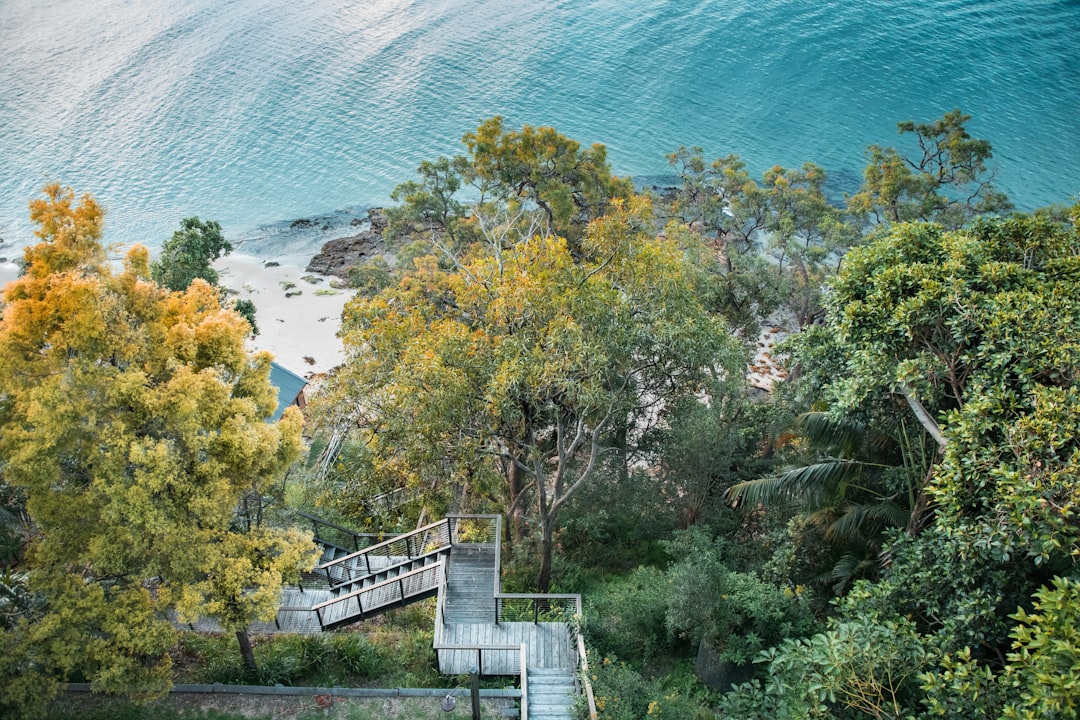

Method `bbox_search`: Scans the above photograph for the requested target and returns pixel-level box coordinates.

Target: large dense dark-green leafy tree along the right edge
[734,205,1080,717]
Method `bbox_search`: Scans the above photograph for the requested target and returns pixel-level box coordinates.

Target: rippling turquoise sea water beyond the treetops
[0,0,1080,255]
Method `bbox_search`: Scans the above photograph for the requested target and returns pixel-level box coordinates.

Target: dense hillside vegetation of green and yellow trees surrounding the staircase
[0,111,1080,720]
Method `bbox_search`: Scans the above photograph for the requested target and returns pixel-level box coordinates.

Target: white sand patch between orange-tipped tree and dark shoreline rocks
[214,253,352,379]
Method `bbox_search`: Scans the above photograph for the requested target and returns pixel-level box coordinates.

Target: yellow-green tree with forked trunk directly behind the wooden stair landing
[319,199,744,589]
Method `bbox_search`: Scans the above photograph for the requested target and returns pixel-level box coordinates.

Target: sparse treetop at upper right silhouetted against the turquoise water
[849,109,1012,228]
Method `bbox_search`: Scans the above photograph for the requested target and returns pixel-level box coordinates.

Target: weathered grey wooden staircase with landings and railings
[199,515,596,720]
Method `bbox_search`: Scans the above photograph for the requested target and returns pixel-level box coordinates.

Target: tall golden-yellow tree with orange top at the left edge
[0,185,313,712]
